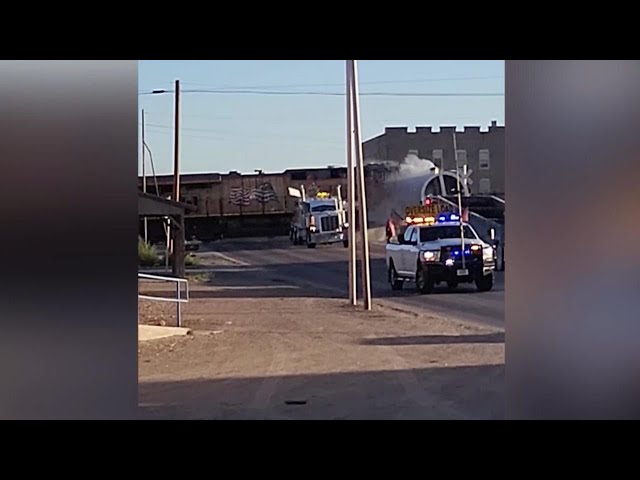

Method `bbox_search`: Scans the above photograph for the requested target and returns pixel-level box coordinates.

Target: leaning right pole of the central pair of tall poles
[347,60,371,310]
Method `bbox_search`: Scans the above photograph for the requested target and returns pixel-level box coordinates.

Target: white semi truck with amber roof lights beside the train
[289,186,349,248]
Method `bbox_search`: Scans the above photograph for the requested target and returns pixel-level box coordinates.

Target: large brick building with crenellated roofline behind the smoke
[363,121,505,196]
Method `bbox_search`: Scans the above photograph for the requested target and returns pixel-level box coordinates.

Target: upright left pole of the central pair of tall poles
[346,61,358,305]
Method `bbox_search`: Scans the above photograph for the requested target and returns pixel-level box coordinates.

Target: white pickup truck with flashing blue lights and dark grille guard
[386,213,495,293]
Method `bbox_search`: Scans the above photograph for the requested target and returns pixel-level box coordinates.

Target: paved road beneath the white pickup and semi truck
[202,238,504,328]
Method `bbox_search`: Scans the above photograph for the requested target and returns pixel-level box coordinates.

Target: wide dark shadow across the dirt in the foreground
[139,365,504,420]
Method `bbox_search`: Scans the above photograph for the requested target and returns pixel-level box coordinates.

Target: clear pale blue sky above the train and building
[138,60,504,175]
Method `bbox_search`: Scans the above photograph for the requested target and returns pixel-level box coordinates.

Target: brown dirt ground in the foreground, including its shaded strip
[139,275,504,419]
